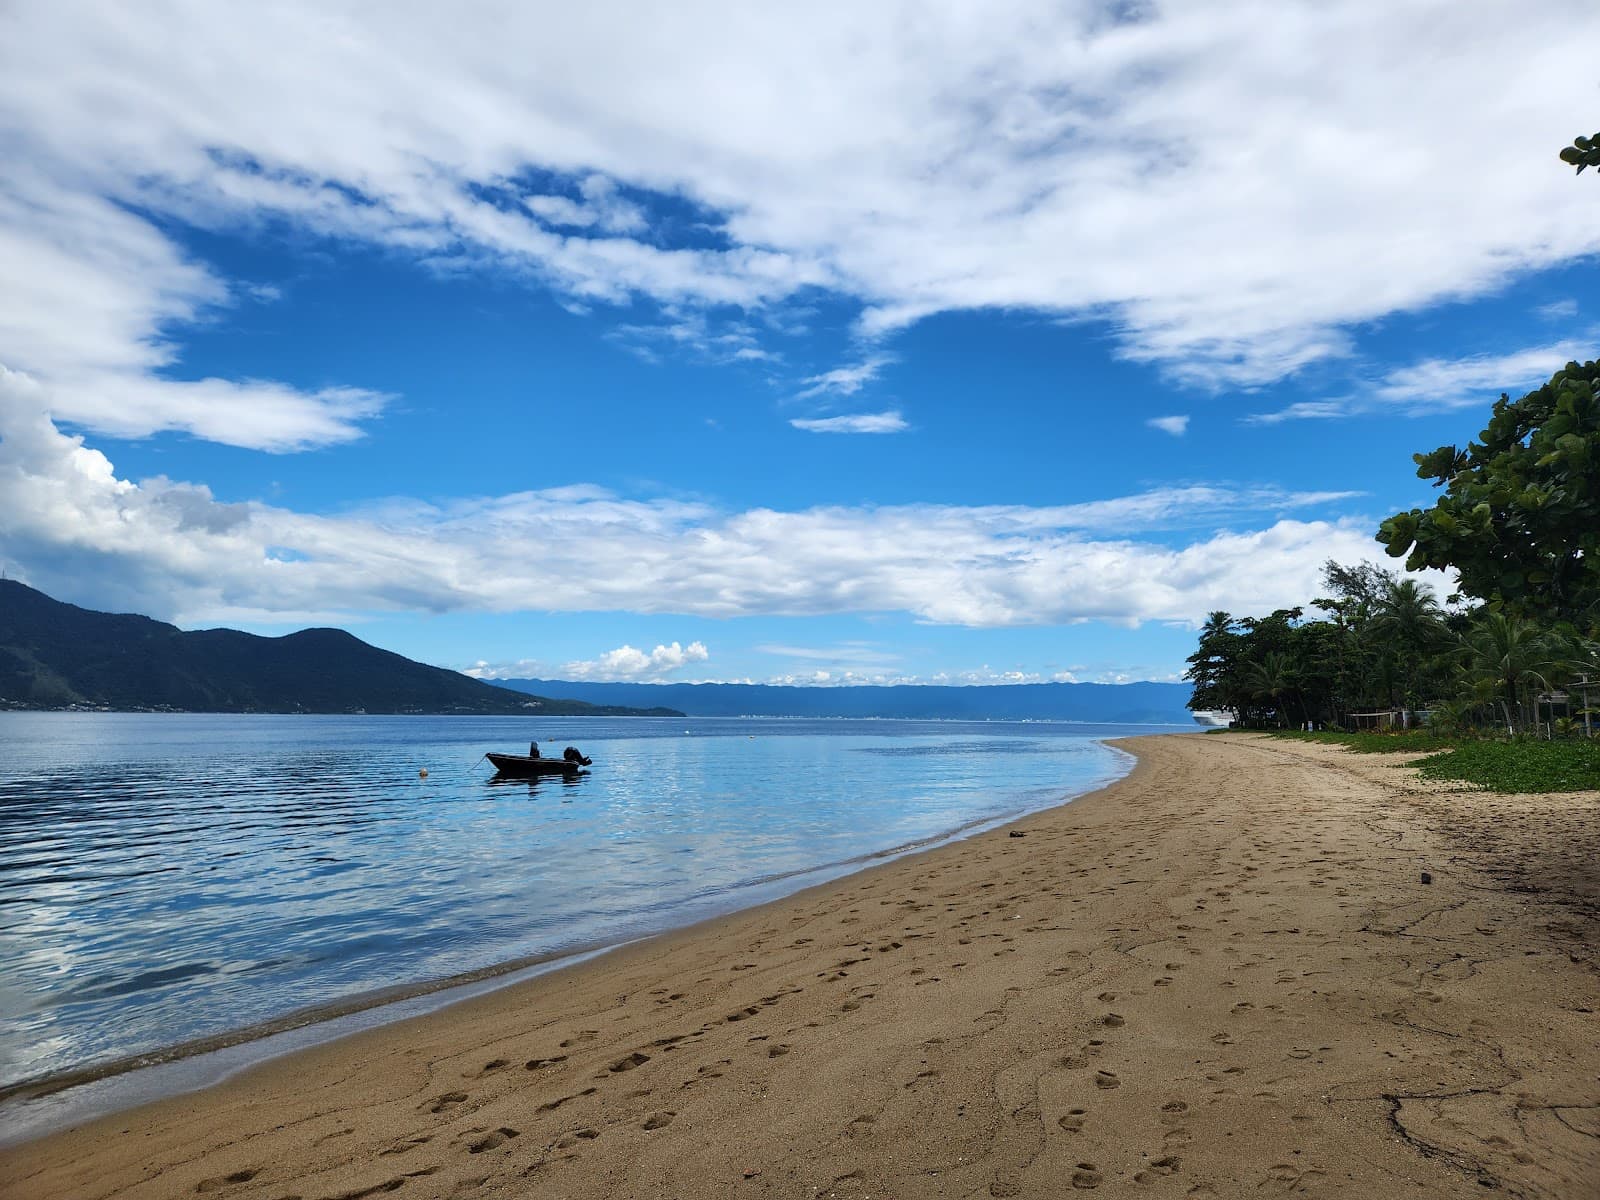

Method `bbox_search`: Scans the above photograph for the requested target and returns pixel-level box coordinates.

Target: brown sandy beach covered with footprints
[0,734,1600,1200]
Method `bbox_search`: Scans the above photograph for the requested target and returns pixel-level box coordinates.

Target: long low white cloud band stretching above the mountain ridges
[0,385,1440,633]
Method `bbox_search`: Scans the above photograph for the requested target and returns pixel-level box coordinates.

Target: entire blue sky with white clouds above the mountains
[0,2,1600,683]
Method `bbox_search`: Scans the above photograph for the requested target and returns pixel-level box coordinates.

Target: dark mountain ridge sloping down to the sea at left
[0,579,682,717]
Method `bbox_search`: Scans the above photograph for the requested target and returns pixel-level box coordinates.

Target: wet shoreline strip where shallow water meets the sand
[0,742,1139,1150]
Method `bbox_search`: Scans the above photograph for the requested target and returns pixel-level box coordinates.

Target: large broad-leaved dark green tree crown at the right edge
[1378,362,1600,626]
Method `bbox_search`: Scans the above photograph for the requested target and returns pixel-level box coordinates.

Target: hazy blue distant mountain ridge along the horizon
[498,678,1194,725]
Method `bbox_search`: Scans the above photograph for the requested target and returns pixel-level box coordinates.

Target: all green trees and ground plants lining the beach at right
[1186,362,1600,790]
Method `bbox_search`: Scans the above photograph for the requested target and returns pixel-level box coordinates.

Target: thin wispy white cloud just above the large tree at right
[1250,339,1595,424]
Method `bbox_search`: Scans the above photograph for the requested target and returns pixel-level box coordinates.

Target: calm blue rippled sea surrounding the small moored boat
[0,712,1162,1083]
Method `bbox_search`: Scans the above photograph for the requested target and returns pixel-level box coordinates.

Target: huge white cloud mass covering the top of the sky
[0,0,1600,409]
